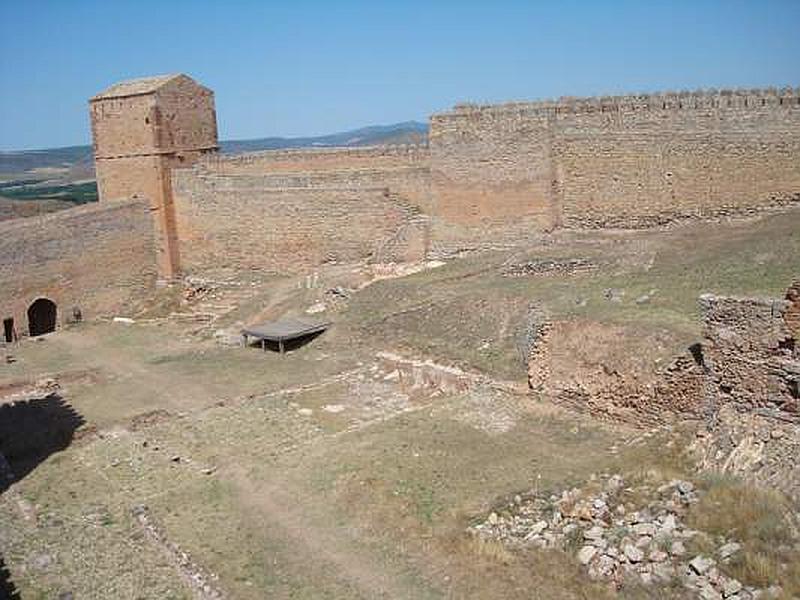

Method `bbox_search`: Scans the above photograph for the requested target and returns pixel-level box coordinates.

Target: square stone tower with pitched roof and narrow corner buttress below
[89,74,218,281]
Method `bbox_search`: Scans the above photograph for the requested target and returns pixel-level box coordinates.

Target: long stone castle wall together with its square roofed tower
[84,77,800,282]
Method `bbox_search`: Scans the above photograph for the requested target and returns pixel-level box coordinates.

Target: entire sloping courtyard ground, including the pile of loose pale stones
[0,212,800,600]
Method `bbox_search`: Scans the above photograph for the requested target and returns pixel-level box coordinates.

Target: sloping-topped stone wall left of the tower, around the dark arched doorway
[0,201,156,334]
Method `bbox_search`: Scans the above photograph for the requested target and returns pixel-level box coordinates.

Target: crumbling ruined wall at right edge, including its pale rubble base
[692,283,800,496]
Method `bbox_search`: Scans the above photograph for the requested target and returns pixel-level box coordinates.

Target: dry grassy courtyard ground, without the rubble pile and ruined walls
[0,212,800,599]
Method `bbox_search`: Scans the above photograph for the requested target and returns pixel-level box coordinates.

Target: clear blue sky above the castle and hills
[0,0,800,150]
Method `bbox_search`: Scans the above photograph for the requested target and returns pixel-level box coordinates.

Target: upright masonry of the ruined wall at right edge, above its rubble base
[700,295,800,421]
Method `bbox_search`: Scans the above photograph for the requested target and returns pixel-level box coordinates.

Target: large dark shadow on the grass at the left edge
[0,394,84,493]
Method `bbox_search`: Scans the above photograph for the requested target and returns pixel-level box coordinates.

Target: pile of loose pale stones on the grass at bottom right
[471,475,779,600]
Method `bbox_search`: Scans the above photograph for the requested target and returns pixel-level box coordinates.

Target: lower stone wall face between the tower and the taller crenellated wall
[174,170,424,274]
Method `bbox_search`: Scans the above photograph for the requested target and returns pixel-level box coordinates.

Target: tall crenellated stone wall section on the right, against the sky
[430,89,800,229]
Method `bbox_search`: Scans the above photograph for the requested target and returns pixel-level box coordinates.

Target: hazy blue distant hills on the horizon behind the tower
[0,121,428,179]
